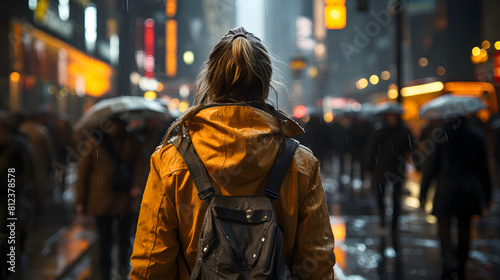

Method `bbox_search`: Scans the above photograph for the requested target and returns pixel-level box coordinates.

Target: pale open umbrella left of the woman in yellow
[74,96,170,131]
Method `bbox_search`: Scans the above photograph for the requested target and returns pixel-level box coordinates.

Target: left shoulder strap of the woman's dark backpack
[171,124,216,201]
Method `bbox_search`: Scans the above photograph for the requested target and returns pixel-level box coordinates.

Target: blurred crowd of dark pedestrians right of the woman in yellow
[301,106,500,279]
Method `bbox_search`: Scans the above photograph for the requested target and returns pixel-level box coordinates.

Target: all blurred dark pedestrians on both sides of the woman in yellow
[0,97,499,279]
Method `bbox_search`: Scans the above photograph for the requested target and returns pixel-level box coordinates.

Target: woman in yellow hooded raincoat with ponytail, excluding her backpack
[131,27,335,279]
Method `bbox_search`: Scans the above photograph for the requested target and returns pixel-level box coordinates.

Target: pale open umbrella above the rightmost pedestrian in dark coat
[419,94,487,120]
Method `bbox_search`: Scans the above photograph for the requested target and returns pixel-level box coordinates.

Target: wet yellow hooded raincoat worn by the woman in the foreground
[130,105,335,280]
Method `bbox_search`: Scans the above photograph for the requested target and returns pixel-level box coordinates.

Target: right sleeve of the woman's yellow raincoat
[290,161,335,279]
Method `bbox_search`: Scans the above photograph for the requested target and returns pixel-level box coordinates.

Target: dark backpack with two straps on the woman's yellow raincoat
[173,127,299,280]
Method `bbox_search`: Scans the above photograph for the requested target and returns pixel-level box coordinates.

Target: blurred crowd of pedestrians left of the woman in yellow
[0,110,168,279]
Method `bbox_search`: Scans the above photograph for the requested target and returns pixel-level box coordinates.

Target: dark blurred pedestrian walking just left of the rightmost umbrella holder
[369,113,413,240]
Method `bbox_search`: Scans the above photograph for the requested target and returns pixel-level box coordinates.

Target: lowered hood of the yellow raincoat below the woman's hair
[186,105,304,191]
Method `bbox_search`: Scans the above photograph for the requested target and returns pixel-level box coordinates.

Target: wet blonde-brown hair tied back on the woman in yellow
[162,27,277,145]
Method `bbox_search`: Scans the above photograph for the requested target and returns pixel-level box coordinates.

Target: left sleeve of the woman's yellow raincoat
[130,153,179,280]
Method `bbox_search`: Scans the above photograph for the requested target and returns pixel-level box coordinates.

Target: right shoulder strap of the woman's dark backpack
[264,138,299,200]
